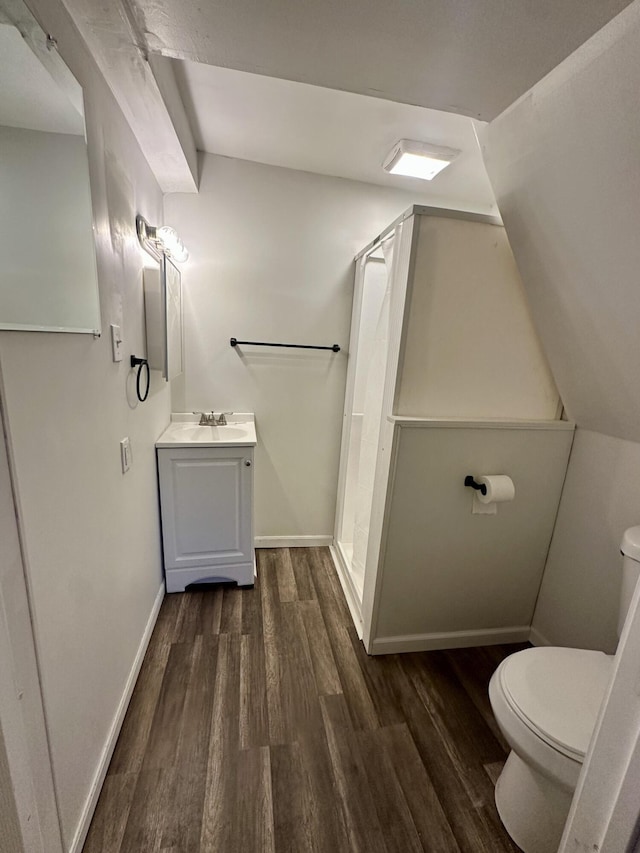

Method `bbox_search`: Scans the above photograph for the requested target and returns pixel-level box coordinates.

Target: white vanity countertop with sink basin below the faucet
[156,412,257,447]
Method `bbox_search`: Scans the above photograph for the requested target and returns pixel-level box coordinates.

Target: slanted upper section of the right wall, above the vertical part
[483,3,640,442]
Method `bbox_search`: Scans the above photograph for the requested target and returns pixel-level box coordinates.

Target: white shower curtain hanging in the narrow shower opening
[351,237,394,595]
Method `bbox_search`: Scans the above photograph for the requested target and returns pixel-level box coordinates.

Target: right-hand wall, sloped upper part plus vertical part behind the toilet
[483,0,640,650]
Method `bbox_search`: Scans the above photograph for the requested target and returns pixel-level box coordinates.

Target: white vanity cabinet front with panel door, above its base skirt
[158,447,253,569]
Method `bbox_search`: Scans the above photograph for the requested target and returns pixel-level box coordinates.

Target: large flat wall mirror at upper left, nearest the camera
[0,0,100,335]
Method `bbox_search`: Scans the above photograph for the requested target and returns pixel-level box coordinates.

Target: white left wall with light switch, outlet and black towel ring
[0,0,170,849]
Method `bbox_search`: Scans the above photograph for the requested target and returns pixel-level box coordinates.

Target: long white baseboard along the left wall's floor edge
[69,581,165,853]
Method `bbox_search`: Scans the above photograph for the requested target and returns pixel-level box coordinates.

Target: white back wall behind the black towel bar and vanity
[165,154,450,537]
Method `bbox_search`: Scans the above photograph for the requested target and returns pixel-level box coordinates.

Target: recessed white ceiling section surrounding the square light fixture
[174,61,495,212]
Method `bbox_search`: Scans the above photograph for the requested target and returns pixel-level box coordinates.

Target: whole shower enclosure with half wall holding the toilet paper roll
[334,207,573,653]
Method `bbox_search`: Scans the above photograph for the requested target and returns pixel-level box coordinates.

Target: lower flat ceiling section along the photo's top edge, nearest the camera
[135,0,630,120]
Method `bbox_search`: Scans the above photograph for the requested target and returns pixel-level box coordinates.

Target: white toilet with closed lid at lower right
[489,527,640,853]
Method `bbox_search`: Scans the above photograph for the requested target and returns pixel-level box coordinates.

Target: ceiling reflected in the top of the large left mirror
[0,24,84,135]
